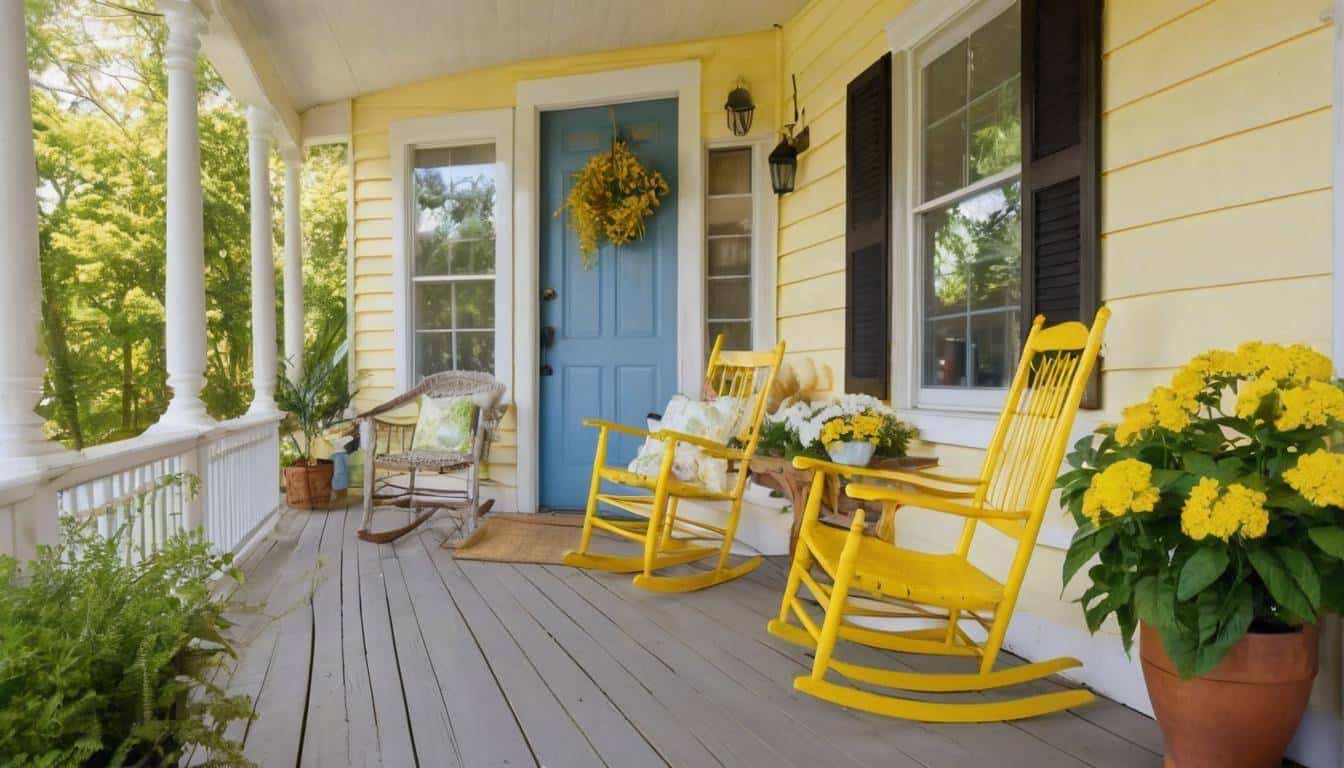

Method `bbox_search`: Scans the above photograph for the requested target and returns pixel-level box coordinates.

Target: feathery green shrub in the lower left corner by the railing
[0,477,251,767]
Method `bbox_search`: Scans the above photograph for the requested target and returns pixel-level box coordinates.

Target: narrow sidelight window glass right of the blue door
[706,147,754,350]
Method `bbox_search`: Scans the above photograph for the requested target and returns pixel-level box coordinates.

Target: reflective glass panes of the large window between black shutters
[915,4,1021,387]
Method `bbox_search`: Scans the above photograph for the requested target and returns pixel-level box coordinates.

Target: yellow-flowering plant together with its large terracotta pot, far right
[1059,342,1344,768]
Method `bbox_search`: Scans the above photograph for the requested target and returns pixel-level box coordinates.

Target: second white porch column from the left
[157,0,215,428]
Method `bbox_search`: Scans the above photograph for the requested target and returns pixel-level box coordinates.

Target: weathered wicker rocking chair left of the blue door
[355,371,505,543]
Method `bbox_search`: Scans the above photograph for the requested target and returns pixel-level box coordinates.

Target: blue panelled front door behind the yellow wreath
[540,100,677,510]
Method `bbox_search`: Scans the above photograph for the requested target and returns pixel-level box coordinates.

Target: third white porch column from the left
[247,106,277,413]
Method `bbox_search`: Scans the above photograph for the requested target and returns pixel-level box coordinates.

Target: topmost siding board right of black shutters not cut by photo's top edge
[1102,28,1333,171]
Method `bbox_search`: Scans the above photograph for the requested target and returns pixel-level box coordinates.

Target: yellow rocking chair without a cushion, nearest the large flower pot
[767,308,1110,722]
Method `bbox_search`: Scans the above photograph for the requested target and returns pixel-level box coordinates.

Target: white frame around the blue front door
[513,61,704,512]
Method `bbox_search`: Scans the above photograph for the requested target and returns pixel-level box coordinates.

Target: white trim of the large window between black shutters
[887,0,1020,449]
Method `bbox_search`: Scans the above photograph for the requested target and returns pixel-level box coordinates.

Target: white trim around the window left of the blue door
[387,109,513,398]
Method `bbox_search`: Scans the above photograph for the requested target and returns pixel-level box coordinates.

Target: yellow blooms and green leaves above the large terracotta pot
[1059,342,1344,678]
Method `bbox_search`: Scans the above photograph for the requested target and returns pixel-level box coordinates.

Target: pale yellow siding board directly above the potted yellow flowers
[1106,276,1331,369]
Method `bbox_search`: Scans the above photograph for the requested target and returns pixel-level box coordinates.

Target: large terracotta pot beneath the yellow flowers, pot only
[1140,624,1317,768]
